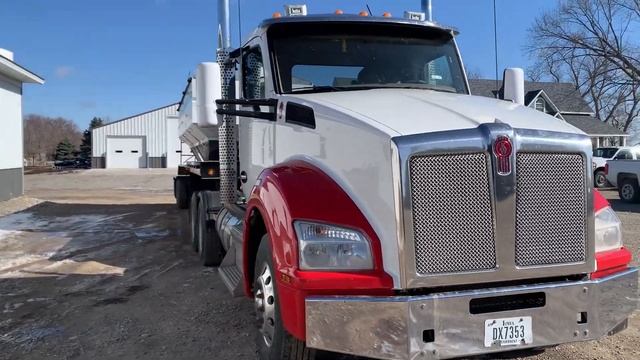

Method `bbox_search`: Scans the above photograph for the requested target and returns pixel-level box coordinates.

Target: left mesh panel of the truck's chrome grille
[409,153,496,275]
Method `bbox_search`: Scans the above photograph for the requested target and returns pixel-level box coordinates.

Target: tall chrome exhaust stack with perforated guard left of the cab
[216,0,238,204]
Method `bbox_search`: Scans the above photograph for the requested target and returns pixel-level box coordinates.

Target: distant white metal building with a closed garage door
[91,104,191,169]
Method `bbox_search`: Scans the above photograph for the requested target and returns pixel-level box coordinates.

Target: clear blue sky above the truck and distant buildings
[0,0,557,128]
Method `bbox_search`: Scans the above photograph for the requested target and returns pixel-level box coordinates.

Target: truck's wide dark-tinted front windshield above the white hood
[269,23,467,94]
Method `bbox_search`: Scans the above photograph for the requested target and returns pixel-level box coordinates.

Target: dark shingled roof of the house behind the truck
[469,79,593,114]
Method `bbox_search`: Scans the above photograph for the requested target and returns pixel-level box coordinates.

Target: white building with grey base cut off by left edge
[0,49,44,201]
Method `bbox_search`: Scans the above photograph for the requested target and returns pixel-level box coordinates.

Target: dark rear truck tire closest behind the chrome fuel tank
[198,191,224,266]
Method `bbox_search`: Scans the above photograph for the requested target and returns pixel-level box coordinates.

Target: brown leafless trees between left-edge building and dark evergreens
[24,114,82,163]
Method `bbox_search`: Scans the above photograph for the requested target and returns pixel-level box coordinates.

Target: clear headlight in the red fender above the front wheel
[293,221,373,270]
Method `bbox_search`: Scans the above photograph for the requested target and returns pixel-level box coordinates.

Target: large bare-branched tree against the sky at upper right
[527,0,640,131]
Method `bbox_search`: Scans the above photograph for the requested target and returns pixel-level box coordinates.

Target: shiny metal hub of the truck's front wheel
[254,264,276,347]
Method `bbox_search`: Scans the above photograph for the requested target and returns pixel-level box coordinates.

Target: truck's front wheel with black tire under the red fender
[253,235,316,360]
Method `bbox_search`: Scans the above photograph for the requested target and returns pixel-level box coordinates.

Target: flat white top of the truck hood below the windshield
[293,89,584,136]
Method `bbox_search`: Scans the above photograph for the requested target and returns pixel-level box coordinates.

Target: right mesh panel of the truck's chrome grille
[515,153,587,266]
